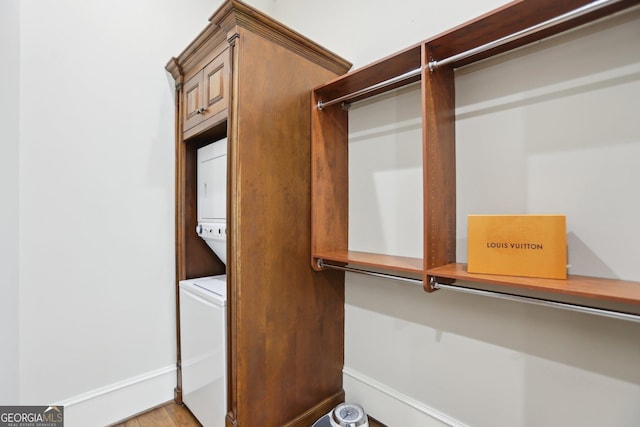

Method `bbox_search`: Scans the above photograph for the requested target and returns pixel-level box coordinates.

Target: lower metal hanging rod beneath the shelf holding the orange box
[430,276,640,323]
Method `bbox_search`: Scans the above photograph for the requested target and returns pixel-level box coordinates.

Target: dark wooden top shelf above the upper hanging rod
[315,0,638,110]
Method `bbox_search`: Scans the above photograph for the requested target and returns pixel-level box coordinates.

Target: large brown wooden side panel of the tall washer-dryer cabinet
[231,30,344,426]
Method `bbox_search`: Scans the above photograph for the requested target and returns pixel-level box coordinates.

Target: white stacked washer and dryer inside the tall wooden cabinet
[179,138,227,427]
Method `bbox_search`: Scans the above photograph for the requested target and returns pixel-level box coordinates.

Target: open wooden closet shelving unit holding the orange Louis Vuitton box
[311,0,640,318]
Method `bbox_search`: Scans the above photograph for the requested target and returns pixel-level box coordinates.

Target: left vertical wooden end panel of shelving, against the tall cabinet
[311,93,349,269]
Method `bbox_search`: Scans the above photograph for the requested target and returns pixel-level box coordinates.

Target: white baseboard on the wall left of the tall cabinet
[56,366,176,427]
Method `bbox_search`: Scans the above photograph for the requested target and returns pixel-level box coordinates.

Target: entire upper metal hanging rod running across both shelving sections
[316,0,623,110]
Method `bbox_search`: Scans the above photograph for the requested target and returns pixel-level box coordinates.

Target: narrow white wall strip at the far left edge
[0,0,20,405]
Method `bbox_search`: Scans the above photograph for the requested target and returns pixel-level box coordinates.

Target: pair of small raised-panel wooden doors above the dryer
[183,49,230,136]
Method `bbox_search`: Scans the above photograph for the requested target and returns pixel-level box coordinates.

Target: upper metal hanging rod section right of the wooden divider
[427,0,622,71]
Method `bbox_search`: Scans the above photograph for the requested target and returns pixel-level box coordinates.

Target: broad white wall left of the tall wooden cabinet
[14,0,270,426]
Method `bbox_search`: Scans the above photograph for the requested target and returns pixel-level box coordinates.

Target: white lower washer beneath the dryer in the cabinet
[180,275,227,427]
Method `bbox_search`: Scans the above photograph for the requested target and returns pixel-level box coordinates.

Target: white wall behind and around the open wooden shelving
[275,0,640,427]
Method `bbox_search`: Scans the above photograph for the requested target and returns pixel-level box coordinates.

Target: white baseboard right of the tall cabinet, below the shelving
[342,367,467,427]
